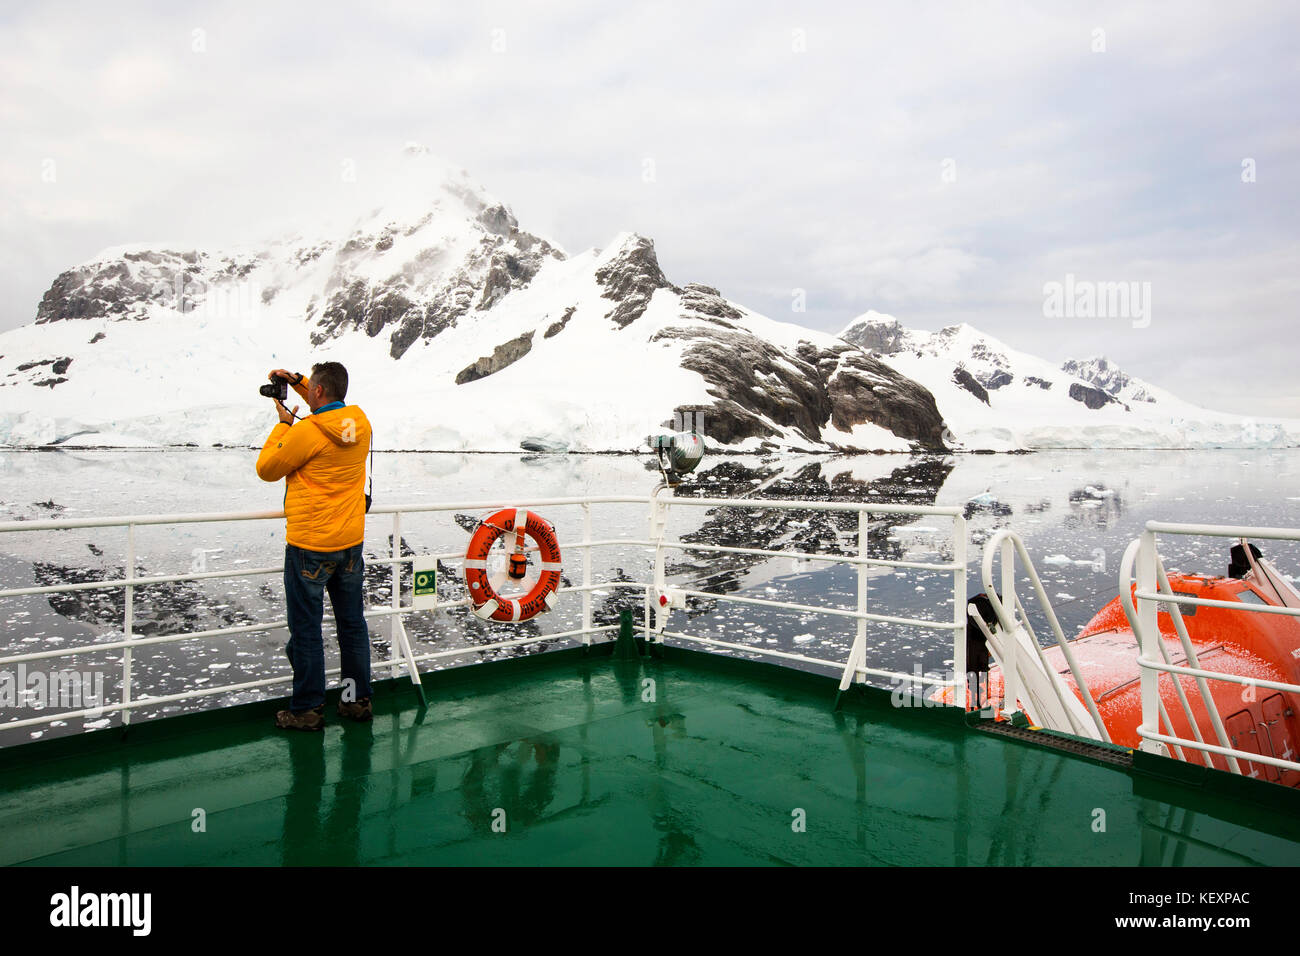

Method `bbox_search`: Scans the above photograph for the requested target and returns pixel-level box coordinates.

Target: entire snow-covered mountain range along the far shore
[0,147,1300,451]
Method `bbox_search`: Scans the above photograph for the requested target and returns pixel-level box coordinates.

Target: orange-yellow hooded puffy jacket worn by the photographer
[257,377,371,551]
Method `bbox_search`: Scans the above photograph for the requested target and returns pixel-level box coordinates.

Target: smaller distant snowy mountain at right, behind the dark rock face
[840,312,1300,450]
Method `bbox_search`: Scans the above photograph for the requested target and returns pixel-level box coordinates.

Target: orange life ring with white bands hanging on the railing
[465,507,560,622]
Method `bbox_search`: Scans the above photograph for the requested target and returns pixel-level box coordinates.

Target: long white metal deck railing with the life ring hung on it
[0,490,966,730]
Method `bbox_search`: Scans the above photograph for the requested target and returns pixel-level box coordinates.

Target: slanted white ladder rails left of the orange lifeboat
[969,528,1110,743]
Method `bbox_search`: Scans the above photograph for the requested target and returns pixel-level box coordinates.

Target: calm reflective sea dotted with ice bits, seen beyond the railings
[0,449,1300,744]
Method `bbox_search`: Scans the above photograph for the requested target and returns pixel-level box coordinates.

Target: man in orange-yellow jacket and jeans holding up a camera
[257,362,372,730]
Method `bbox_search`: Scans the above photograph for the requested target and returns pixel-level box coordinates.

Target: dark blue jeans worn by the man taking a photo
[285,544,371,713]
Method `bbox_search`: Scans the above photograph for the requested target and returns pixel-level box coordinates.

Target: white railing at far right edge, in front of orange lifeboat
[1119,522,1300,775]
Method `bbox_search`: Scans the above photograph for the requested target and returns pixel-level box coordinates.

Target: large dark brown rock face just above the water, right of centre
[650,326,944,449]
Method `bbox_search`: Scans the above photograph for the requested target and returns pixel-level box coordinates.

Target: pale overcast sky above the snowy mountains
[0,0,1300,418]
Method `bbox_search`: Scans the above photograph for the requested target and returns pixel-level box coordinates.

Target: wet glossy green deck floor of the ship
[0,649,1300,866]
